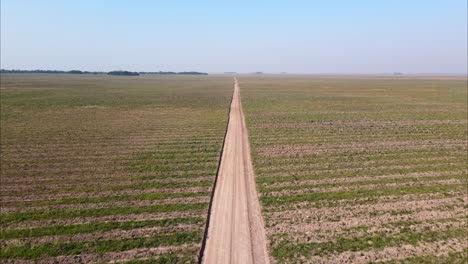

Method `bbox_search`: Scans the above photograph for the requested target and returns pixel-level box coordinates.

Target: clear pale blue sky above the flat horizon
[1,0,467,73]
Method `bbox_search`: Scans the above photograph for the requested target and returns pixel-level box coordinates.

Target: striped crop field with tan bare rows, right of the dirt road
[239,75,468,263]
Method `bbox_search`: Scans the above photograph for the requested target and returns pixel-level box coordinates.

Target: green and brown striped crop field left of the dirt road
[0,74,232,263]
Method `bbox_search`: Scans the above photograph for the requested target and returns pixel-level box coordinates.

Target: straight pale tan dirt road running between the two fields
[202,79,269,264]
